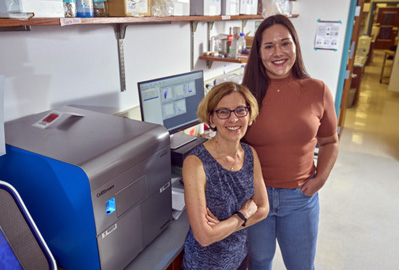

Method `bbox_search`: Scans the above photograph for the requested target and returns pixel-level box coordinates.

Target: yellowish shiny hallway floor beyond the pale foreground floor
[340,50,399,160]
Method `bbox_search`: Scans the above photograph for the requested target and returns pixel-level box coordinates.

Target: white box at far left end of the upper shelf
[0,0,64,18]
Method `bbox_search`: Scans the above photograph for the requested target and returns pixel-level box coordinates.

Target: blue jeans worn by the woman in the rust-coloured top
[248,187,319,270]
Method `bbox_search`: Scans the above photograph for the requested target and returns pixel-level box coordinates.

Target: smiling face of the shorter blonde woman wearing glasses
[210,92,249,142]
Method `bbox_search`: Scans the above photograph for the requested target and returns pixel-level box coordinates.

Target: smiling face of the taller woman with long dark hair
[259,24,296,79]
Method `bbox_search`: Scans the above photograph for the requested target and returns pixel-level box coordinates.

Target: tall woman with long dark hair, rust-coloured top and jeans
[243,15,338,270]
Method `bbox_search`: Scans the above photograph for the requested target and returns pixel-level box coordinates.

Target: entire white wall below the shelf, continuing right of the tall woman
[0,0,349,121]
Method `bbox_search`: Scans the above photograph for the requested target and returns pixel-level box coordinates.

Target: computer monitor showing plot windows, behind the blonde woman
[138,70,204,134]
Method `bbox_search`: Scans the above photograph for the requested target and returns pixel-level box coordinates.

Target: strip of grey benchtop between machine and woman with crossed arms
[125,211,190,270]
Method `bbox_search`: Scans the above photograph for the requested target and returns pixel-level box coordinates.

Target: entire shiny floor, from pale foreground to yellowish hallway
[273,50,399,270]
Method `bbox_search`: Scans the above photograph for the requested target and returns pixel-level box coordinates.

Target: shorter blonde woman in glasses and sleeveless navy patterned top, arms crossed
[183,82,269,270]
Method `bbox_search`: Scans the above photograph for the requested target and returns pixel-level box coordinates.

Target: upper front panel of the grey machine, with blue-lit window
[92,148,172,235]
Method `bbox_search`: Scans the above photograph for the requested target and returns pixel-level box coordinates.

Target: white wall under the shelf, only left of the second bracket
[0,24,190,121]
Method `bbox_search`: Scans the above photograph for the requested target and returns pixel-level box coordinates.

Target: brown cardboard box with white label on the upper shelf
[108,0,151,17]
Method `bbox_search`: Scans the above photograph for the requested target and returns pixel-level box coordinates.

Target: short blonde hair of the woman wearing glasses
[197,82,259,127]
